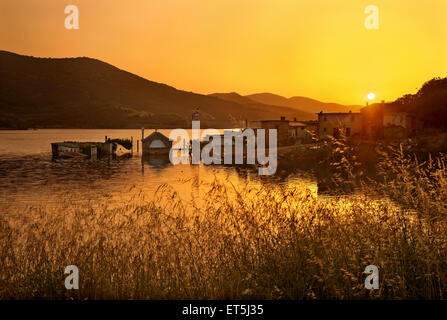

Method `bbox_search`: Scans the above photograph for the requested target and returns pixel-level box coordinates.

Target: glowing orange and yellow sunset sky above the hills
[0,0,447,104]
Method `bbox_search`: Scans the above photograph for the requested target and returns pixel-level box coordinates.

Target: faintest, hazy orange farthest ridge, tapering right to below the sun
[245,93,362,114]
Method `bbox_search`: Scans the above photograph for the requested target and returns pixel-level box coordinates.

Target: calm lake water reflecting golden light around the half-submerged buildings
[0,129,318,208]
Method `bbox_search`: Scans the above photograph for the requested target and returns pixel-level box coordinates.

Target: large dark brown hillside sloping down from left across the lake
[0,51,312,128]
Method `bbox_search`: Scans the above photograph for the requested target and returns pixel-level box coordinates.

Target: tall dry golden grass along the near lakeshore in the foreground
[0,145,447,299]
